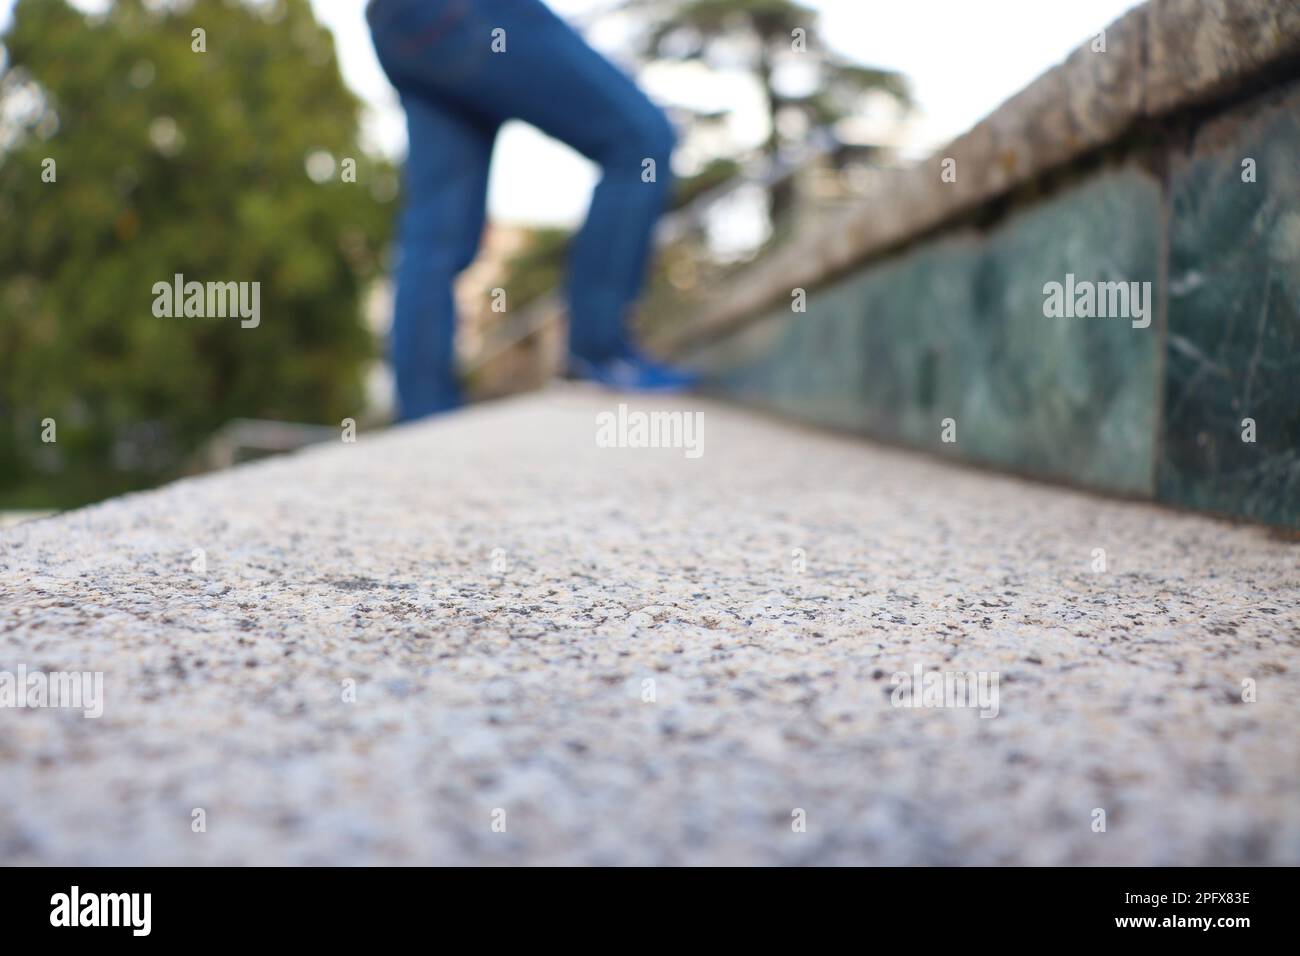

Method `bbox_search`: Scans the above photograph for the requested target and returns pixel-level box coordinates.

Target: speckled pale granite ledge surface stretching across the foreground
[0,390,1300,864]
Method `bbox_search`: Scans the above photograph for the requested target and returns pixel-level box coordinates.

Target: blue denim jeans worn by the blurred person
[367,0,675,420]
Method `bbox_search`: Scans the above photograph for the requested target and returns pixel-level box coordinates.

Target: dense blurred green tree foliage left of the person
[0,0,395,505]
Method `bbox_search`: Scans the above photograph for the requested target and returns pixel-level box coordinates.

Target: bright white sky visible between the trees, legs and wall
[0,0,1138,225]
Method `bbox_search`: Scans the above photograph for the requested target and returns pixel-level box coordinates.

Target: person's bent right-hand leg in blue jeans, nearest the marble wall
[371,0,675,362]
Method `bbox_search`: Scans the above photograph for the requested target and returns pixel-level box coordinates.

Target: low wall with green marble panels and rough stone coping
[667,0,1300,527]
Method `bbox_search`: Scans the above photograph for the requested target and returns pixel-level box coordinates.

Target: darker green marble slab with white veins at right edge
[1158,85,1300,527]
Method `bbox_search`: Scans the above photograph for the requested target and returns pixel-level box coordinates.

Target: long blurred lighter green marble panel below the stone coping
[696,169,1160,496]
